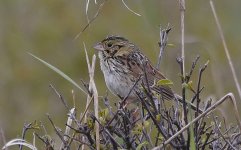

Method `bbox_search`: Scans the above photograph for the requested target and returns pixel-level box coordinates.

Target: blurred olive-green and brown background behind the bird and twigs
[0,0,241,145]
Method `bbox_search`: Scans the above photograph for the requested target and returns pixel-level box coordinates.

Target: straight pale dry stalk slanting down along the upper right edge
[210,0,241,100]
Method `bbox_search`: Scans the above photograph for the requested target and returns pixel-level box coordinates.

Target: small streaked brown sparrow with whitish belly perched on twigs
[94,35,203,113]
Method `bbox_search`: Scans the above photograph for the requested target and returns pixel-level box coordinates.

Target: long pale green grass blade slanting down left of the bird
[28,53,87,94]
